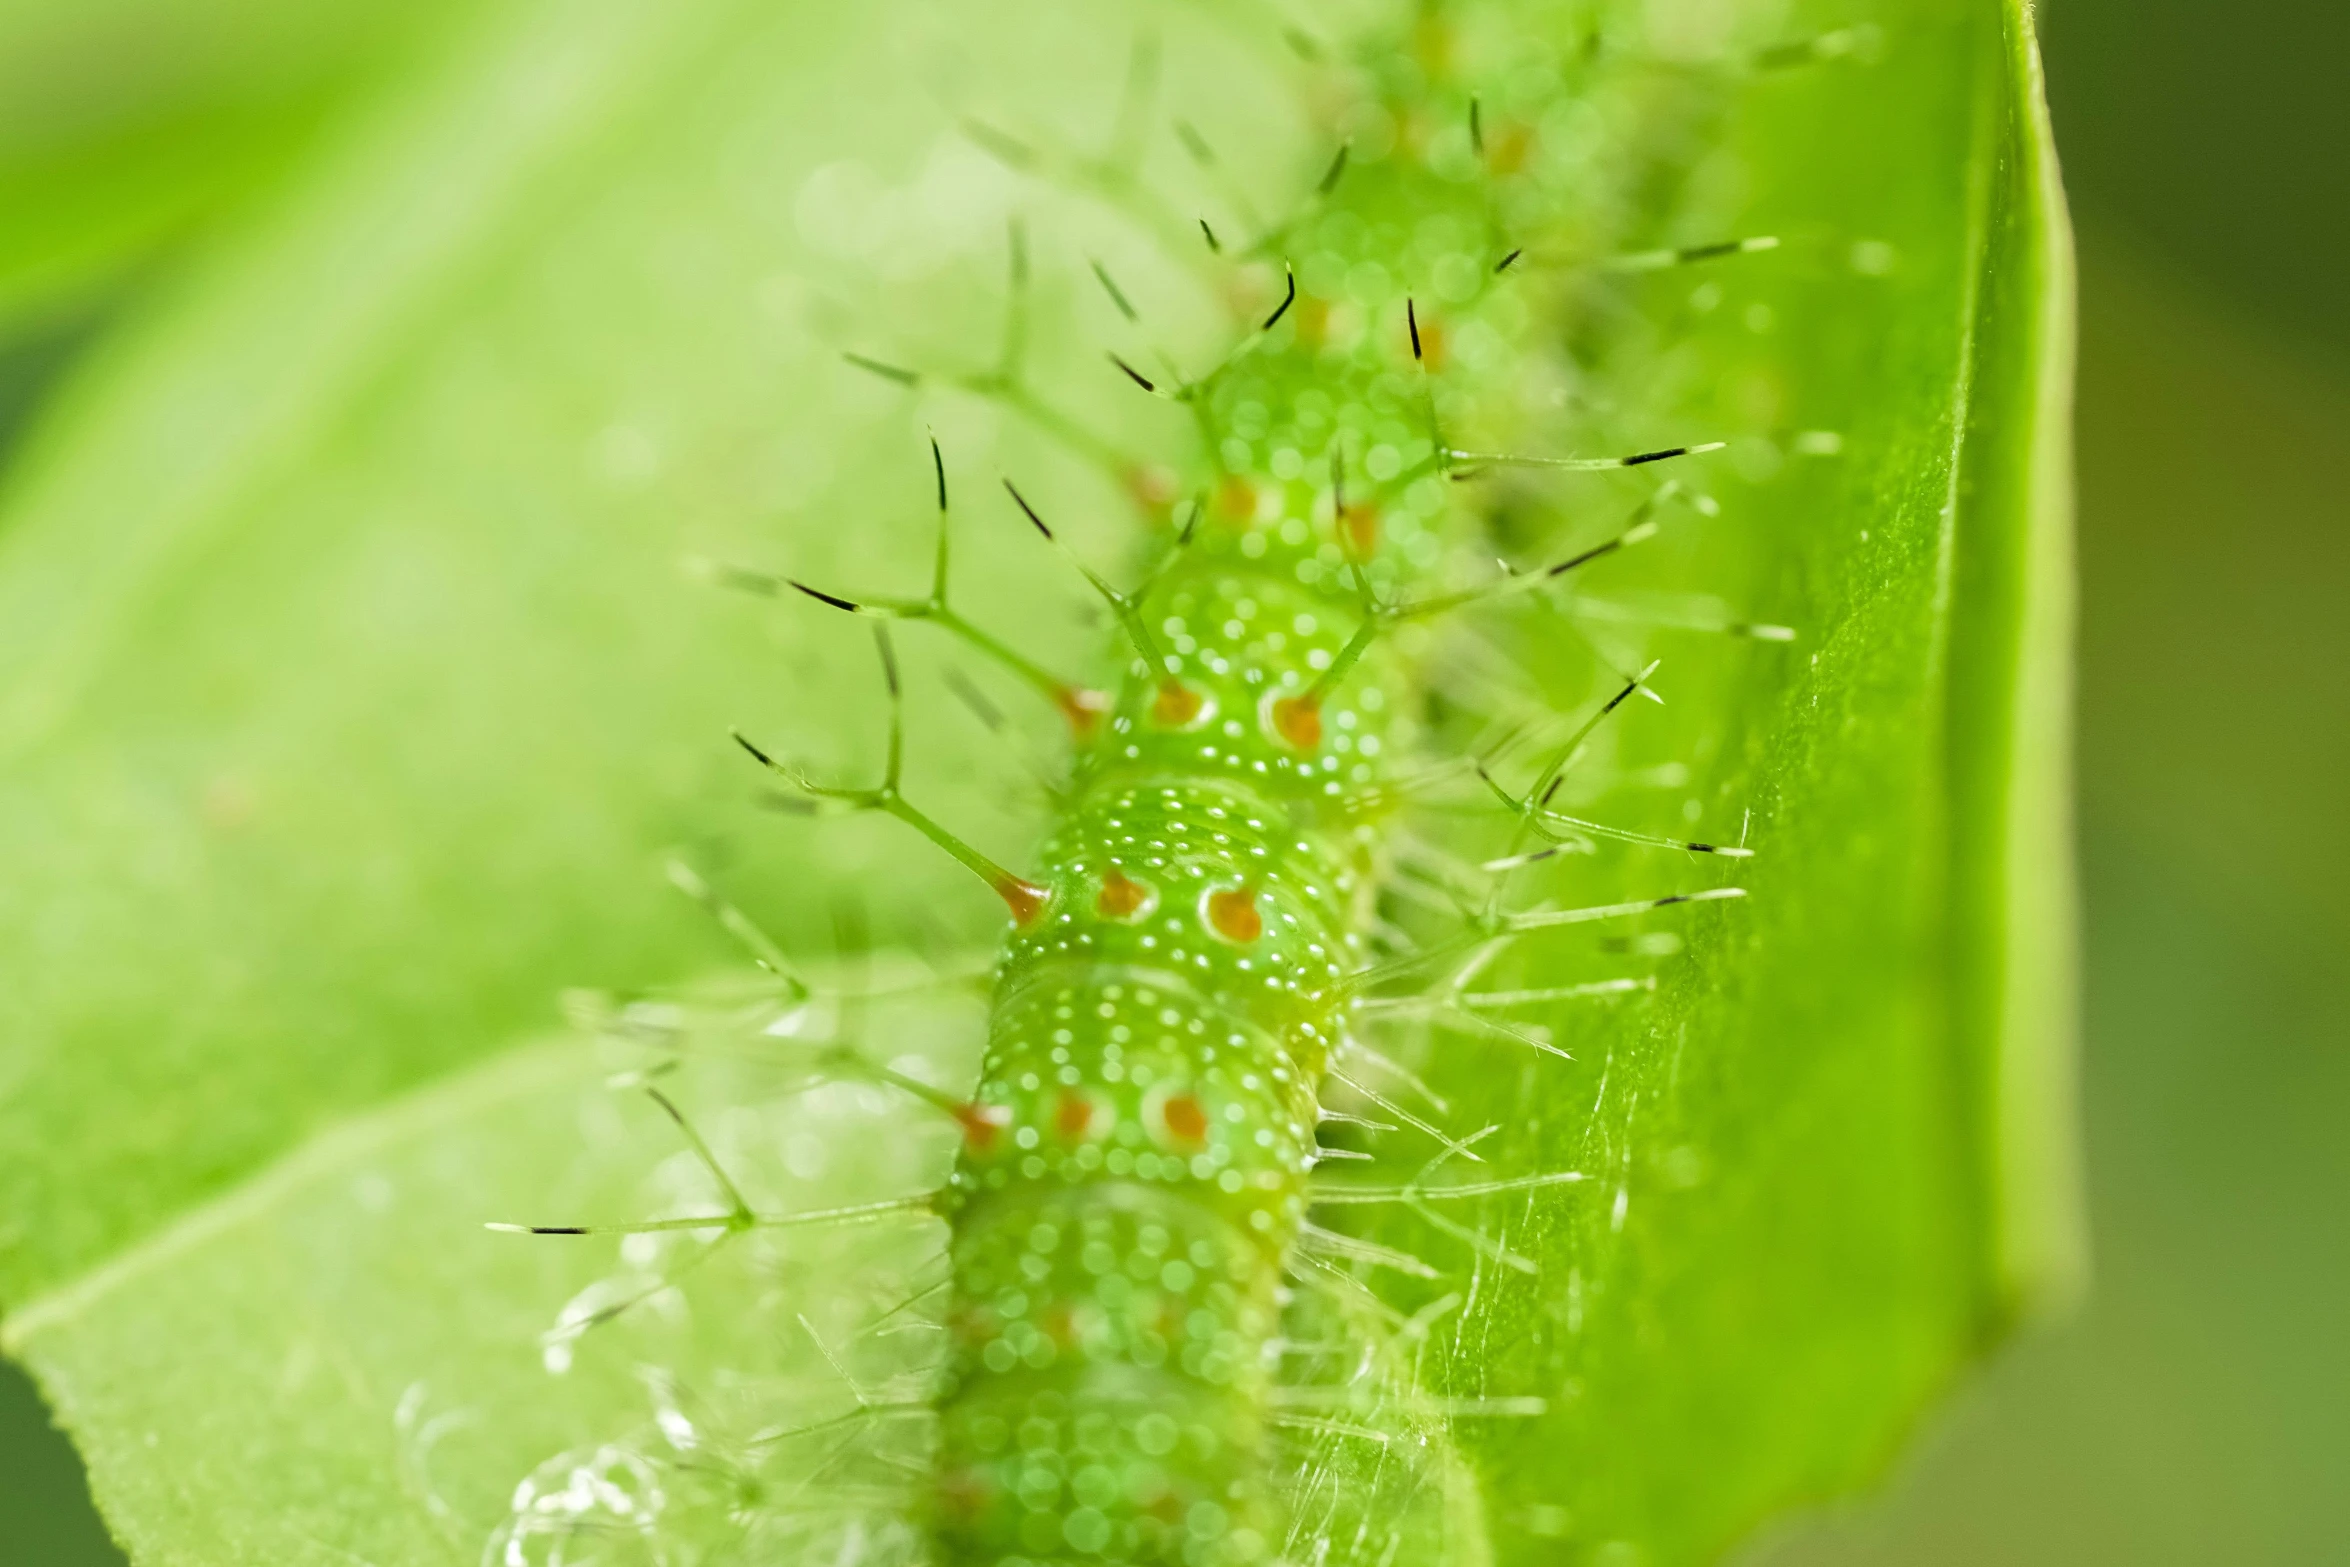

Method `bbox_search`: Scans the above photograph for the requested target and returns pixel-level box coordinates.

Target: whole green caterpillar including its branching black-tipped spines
[491,0,1779,1567]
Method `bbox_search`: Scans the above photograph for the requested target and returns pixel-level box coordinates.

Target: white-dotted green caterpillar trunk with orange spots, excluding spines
[916,33,1748,1567]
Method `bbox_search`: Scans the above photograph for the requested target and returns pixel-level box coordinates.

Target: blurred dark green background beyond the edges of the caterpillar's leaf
[0,0,2350,1567]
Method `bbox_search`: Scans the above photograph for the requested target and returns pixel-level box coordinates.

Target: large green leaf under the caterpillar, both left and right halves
[0,0,2070,1565]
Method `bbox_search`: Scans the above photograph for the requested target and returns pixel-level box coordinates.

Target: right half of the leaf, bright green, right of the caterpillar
[1334,7,2082,1562]
